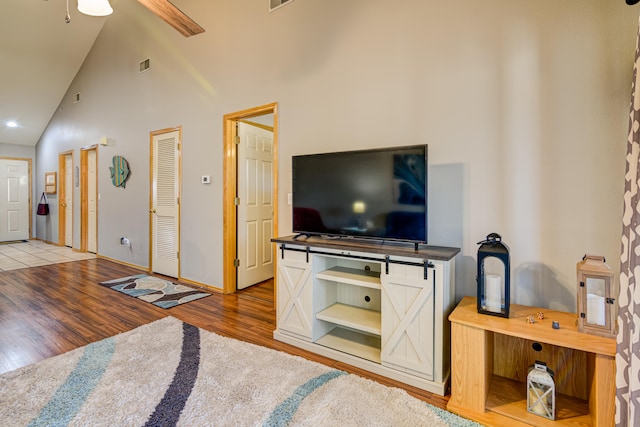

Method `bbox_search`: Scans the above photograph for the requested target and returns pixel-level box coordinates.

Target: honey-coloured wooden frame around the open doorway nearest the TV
[222,102,278,294]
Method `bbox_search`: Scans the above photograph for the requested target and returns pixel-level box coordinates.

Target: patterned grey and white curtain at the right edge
[616,16,640,427]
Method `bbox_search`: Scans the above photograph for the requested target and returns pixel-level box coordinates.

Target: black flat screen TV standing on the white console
[292,145,427,244]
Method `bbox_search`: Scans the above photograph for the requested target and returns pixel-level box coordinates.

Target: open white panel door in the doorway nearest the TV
[237,122,273,289]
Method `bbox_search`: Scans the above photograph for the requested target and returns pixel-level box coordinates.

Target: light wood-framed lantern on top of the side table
[576,255,618,337]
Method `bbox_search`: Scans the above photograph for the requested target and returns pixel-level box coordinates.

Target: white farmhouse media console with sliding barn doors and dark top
[272,236,460,395]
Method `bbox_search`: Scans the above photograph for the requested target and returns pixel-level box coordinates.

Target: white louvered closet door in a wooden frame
[151,131,180,277]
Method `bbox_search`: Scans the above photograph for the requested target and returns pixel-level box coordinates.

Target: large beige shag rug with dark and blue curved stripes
[0,317,477,427]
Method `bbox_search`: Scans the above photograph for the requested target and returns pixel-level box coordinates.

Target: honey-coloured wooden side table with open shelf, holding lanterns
[447,297,616,427]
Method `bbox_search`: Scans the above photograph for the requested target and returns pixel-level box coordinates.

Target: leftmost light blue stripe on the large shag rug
[29,338,116,427]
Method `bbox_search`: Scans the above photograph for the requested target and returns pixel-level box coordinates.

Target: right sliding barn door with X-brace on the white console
[380,264,435,380]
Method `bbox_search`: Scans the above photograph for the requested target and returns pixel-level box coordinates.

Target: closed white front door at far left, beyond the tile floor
[0,159,29,242]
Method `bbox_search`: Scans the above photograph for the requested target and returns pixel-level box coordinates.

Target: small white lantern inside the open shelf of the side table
[527,360,556,420]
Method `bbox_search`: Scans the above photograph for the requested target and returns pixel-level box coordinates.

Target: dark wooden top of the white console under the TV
[271,236,460,261]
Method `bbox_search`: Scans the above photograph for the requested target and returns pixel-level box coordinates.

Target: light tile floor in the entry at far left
[0,240,96,271]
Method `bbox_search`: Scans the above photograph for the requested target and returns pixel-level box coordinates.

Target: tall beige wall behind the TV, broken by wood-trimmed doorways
[38,0,639,311]
